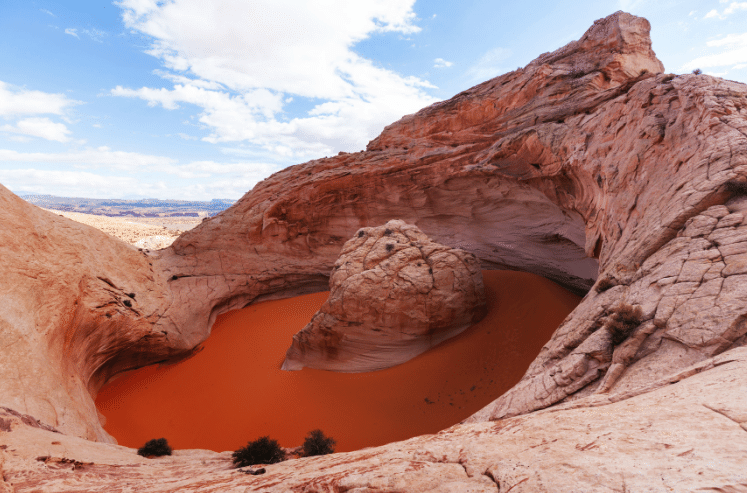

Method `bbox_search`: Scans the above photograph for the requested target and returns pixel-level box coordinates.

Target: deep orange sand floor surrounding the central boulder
[96,271,580,451]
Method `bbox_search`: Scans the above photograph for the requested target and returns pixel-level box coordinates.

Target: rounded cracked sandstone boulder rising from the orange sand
[282,220,486,372]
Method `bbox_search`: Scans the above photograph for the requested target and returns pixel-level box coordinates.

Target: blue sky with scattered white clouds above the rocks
[0,0,747,200]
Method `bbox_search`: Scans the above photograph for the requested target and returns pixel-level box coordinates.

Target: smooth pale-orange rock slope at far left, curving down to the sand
[0,185,188,441]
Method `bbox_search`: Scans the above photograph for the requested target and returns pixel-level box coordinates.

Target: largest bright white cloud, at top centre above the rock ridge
[112,0,435,157]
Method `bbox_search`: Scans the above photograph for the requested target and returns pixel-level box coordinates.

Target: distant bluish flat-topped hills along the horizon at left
[18,194,235,217]
